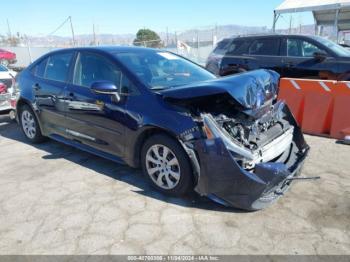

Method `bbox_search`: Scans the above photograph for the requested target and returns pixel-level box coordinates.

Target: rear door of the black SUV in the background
[249,37,282,73]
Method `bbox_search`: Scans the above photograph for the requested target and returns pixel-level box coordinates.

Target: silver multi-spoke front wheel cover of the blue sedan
[146,145,181,190]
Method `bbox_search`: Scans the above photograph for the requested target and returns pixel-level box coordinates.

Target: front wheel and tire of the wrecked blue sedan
[141,135,194,197]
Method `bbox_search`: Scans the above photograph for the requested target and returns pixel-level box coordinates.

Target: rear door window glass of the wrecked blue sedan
[44,53,73,82]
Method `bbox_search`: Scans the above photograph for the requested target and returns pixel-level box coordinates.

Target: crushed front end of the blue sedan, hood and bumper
[163,70,309,210]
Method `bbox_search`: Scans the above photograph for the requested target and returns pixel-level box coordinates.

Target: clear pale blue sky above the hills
[0,0,312,36]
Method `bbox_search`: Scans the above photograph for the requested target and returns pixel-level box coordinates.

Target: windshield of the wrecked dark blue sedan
[115,50,216,90]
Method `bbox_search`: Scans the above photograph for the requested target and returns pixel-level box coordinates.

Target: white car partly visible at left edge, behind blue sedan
[0,65,17,119]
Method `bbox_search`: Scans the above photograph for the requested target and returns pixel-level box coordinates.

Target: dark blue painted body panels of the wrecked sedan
[18,47,307,209]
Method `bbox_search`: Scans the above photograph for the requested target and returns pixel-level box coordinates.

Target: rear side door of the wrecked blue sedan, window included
[32,51,74,136]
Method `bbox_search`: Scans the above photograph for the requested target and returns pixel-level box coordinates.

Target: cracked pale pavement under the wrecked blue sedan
[0,116,350,255]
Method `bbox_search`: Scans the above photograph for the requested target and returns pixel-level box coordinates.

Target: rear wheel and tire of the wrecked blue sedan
[19,105,45,144]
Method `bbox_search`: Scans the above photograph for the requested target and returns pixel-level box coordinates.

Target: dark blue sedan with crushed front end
[17,47,309,210]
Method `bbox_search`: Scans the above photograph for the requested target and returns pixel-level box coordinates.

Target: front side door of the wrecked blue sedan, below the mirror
[66,51,125,157]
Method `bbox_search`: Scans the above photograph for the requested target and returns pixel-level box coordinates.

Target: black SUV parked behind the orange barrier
[206,35,350,80]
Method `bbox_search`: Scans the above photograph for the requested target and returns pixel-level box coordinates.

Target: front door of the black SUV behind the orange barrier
[282,37,335,79]
